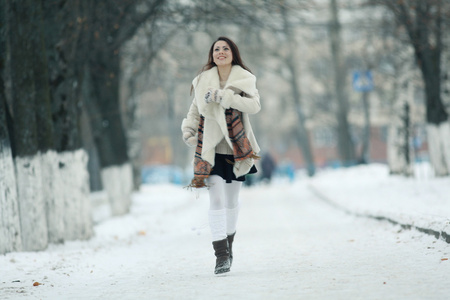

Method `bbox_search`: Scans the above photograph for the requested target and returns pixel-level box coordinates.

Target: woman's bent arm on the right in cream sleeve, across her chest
[220,89,261,114]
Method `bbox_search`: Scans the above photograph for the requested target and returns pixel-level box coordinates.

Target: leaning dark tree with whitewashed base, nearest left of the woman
[85,0,165,215]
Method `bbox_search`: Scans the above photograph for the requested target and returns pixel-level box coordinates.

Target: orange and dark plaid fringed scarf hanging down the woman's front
[188,108,259,188]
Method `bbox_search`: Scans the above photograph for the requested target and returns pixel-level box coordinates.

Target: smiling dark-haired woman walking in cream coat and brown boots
[181,37,261,274]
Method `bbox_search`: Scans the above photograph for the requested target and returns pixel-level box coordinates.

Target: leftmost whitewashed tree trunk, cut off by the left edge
[0,0,22,254]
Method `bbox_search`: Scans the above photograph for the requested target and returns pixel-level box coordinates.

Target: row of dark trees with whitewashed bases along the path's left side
[0,0,165,253]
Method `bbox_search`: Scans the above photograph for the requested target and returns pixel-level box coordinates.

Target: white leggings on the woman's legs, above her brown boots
[208,175,242,241]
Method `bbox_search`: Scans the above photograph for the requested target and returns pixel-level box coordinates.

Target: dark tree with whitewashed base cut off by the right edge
[372,0,450,176]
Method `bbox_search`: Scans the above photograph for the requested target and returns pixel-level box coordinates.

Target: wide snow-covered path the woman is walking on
[0,182,450,299]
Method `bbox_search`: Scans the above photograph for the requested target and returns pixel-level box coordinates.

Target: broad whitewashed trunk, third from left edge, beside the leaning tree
[43,1,93,242]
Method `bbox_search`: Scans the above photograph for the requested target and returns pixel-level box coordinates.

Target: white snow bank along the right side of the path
[309,164,450,238]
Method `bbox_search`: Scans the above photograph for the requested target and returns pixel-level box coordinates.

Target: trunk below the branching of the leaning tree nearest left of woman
[90,47,133,215]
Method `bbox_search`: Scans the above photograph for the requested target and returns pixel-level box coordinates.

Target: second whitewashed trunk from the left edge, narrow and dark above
[10,0,48,251]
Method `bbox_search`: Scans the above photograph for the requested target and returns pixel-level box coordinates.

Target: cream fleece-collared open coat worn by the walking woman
[181,65,261,177]
